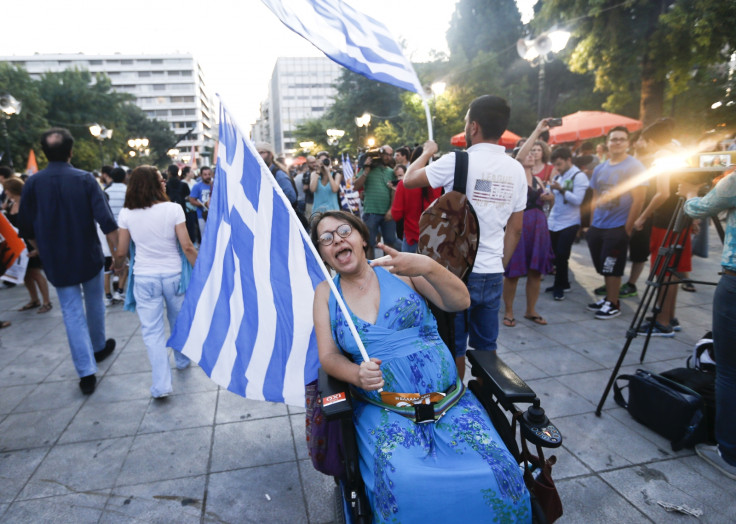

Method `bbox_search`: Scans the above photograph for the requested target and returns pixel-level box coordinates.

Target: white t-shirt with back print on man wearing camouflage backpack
[426,143,526,273]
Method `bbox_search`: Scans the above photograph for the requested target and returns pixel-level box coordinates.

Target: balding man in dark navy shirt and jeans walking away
[19,128,118,395]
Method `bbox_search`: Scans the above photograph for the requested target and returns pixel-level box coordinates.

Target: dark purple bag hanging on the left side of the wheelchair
[305,380,345,477]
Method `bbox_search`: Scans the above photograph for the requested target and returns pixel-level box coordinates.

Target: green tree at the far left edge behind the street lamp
[0,62,48,171]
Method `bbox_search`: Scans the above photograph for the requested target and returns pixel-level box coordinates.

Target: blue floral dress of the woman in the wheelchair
[329,267,531,524]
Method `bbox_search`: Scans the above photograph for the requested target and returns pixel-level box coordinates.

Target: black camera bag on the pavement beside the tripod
[613,369,708,451]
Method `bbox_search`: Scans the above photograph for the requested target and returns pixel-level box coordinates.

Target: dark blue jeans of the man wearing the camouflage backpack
[455,273,503,357]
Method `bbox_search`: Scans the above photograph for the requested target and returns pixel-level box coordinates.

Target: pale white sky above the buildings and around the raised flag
[2,0,536,128]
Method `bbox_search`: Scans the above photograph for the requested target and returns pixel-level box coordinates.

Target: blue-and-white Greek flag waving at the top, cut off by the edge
[262,0,424,96]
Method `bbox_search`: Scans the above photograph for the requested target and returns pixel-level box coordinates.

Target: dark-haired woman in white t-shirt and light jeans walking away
[115,166,197,398]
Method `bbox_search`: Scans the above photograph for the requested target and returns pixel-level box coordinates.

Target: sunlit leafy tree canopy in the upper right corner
[534,0,736,124]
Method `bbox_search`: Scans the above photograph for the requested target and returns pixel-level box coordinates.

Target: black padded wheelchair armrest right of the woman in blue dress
[467,350,536,405]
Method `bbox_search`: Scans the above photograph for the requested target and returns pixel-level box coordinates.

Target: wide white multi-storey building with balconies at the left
[0,53,217,165]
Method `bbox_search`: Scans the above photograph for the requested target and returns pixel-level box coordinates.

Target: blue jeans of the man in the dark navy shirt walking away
[56,270,105,377]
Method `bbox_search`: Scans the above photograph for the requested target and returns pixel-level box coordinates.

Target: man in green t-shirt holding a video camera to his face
[354,146,401,258]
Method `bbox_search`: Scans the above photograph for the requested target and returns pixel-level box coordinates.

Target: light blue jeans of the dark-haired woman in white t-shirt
[133,273,189,397]
